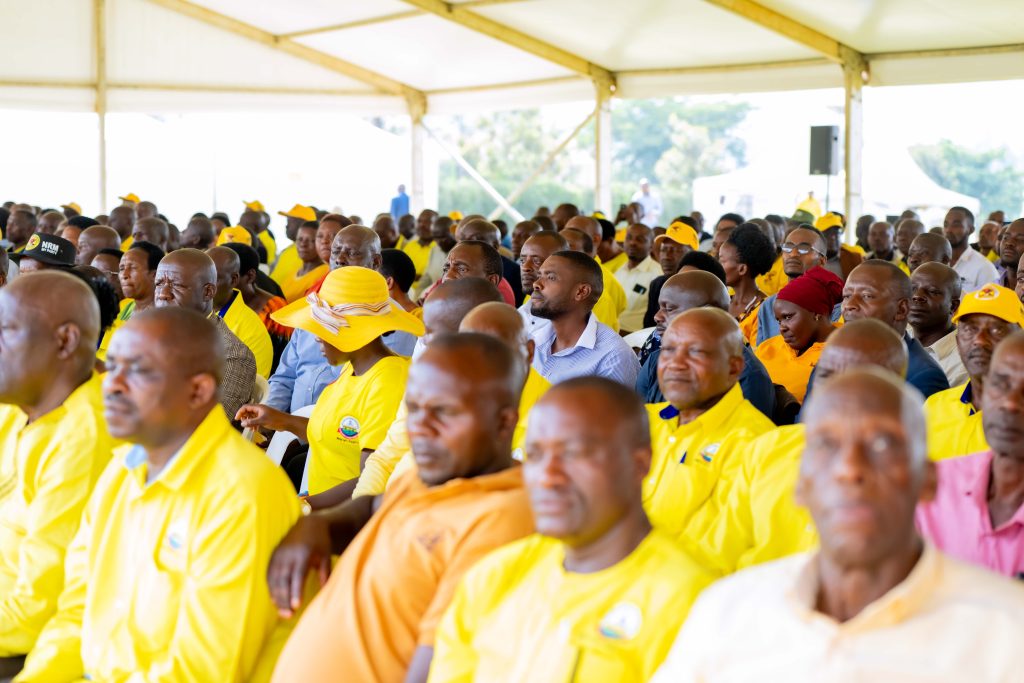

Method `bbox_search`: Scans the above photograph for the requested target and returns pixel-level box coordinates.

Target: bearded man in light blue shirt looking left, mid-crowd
[529,251,640,390]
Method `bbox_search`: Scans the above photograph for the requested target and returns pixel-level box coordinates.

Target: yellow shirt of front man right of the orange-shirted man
[427,530,711,683]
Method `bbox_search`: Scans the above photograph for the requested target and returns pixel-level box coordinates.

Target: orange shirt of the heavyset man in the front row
[273,467,534,683]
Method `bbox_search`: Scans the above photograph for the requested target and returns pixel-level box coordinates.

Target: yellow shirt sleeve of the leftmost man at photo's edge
[0,436,101,655]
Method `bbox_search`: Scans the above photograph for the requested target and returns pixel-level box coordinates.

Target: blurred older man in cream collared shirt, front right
[652,369,1024,683]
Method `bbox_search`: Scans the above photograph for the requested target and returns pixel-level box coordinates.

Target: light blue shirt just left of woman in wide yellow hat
[263,330,341,413]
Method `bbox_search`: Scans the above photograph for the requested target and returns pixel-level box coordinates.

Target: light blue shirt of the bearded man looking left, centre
[534,315,640,389]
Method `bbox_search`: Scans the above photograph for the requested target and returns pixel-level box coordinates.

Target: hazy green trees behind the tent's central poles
[438,98,750,220]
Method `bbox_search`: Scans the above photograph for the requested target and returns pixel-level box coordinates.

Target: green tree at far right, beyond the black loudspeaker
[910,139,1024,216]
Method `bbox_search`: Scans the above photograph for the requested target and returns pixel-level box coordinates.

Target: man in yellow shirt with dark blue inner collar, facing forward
[643,308,774,538]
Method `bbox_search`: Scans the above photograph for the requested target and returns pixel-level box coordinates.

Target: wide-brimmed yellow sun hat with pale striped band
[270,265,424,353]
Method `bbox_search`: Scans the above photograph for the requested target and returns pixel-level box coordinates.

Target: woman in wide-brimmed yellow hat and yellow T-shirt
[236,265,424,495]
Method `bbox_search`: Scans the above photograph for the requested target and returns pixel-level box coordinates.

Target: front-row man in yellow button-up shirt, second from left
[15,307,299,683]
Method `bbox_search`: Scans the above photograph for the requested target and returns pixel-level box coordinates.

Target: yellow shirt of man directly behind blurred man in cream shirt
[685,425,818,575]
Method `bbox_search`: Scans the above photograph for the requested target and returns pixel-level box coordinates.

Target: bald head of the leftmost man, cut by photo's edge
[0,270,99,411]
